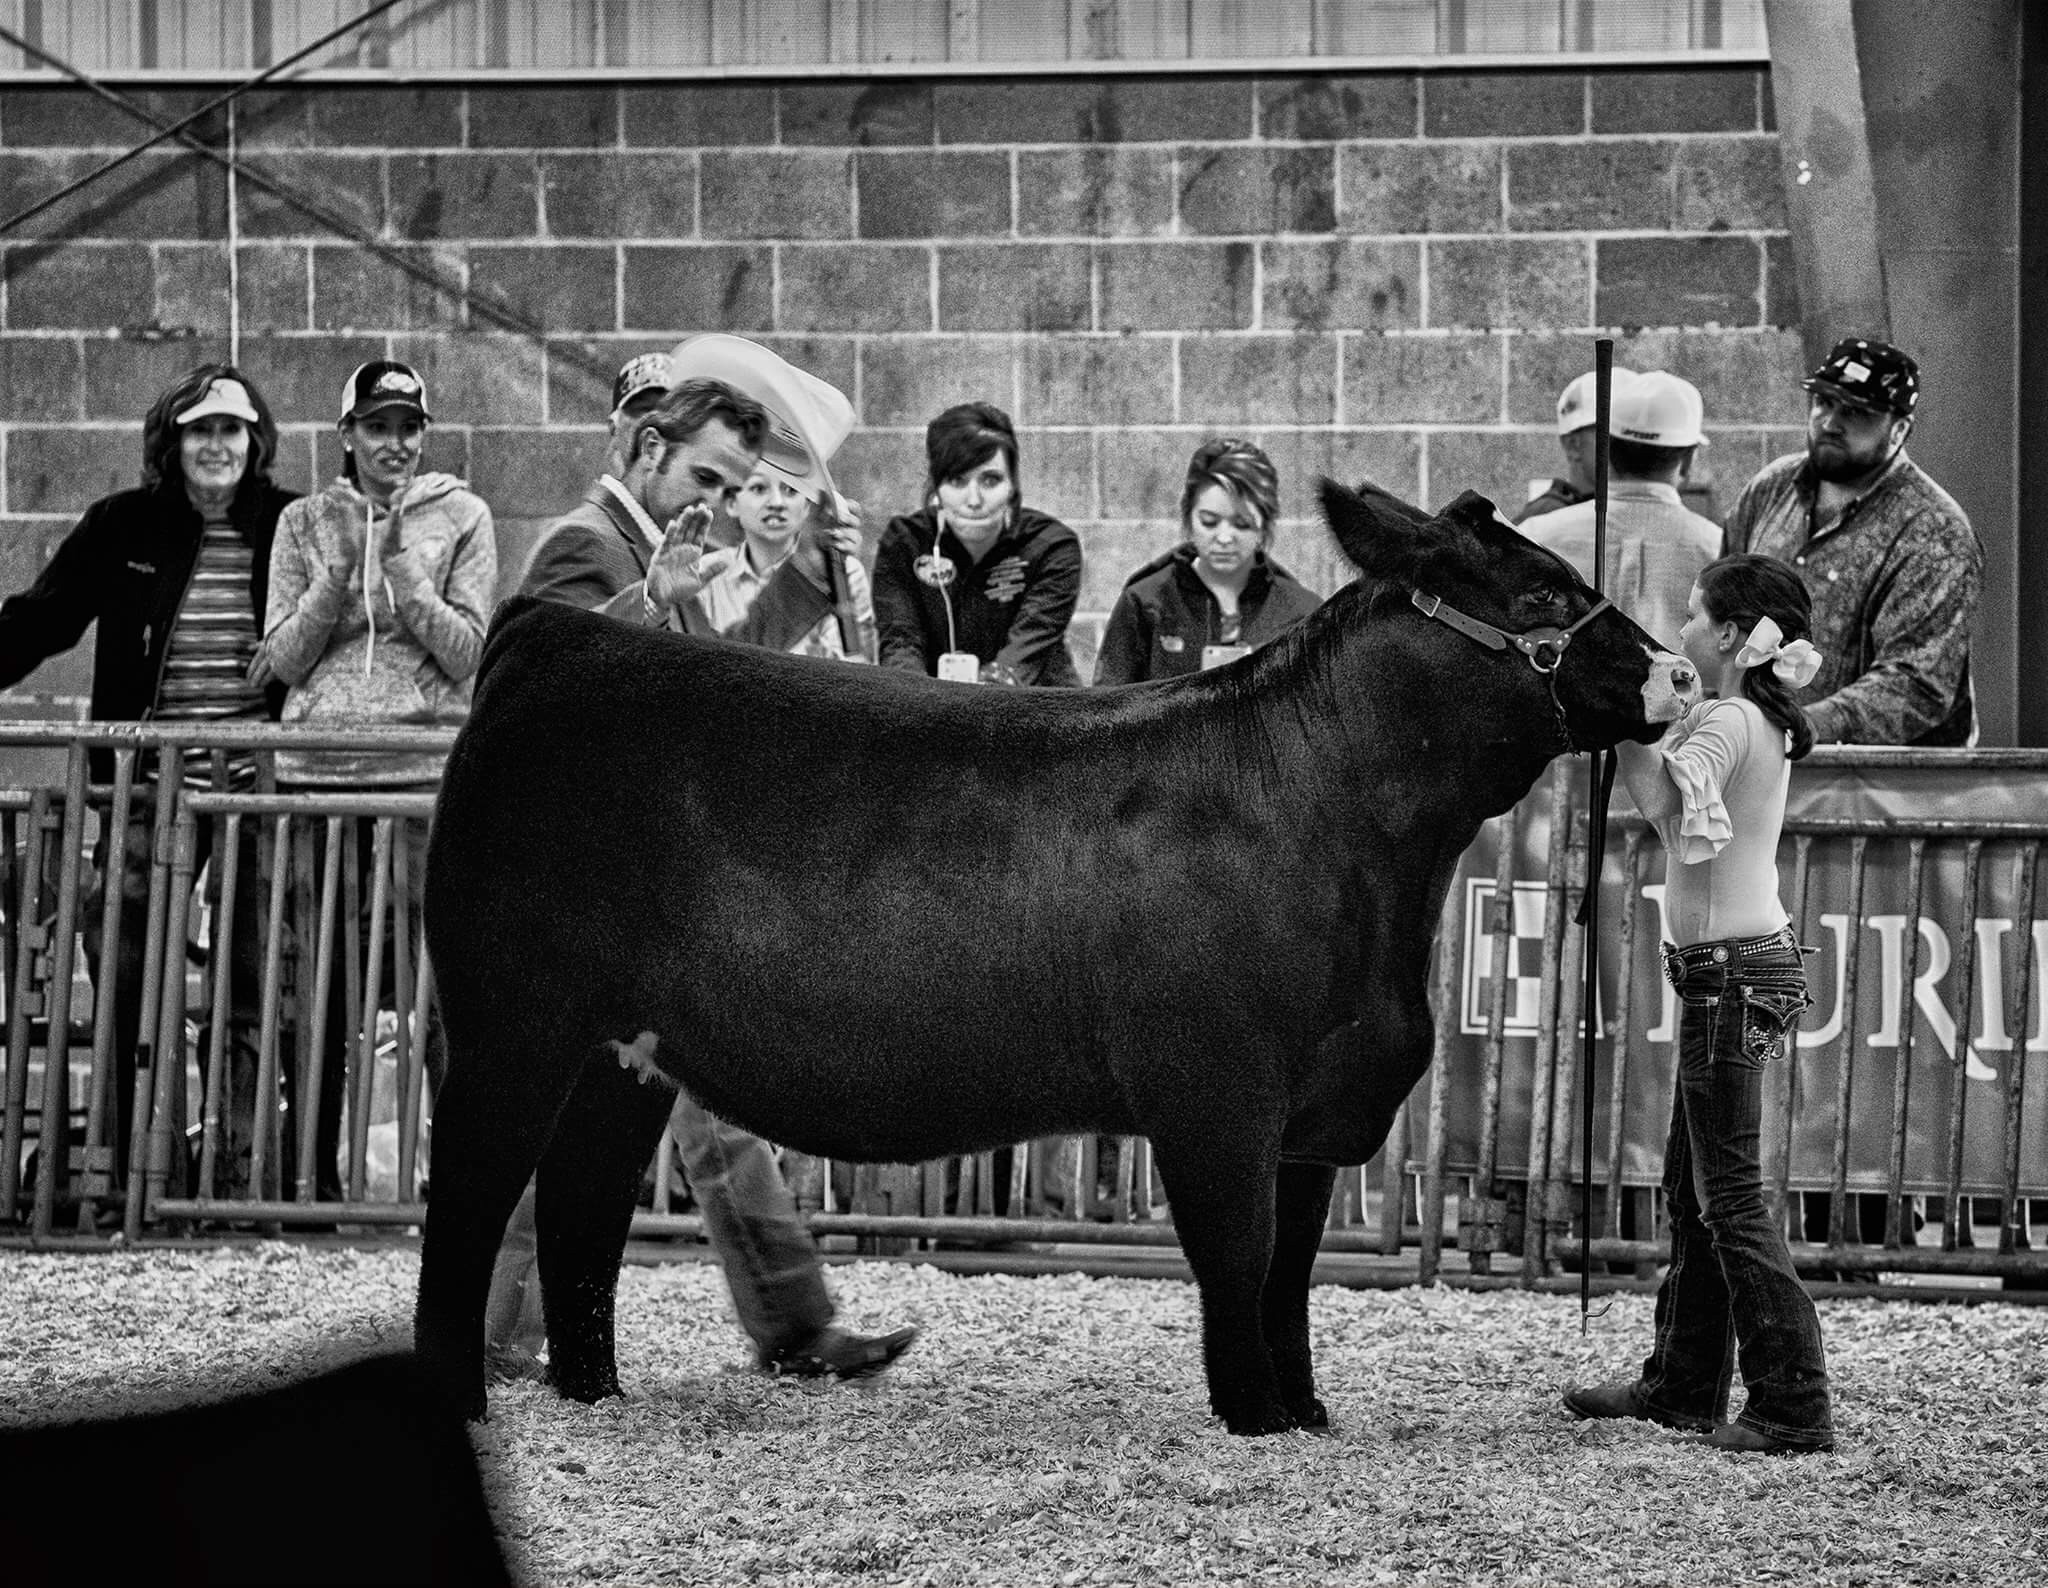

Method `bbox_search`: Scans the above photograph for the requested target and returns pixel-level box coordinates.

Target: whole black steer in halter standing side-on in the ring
[416,482,1690,1434]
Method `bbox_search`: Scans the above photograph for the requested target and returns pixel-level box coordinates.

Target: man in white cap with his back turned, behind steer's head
[1522,369,1720,650]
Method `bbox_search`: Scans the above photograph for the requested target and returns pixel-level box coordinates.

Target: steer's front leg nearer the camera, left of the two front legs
[1153,1137,1296,1434]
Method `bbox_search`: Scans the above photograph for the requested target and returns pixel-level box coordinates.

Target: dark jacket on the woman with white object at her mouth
[874,508,1081,688]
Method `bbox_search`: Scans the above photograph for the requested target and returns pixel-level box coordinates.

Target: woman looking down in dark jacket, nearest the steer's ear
[1096,436,1319,684]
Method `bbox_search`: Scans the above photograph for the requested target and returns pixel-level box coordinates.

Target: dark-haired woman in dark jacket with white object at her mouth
[874,402,1081,684]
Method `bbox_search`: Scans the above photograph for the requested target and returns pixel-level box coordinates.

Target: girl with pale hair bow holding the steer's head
[1565,555,1835,1453]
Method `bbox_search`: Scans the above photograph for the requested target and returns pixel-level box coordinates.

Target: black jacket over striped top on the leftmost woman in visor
[0,479,295,779]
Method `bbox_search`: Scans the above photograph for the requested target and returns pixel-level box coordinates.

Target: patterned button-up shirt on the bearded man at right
[1726,453,1985,744]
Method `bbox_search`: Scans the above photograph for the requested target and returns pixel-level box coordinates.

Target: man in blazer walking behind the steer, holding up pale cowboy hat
[485,336,918,1379]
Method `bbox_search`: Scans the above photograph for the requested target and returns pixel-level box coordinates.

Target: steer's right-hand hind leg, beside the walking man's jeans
[535,1053,676,1402]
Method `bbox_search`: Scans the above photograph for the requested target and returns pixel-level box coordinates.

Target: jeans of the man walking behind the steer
[483,1092,834,1361]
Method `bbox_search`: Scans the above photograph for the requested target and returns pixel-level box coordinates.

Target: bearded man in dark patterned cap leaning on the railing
[1724,336,1985,744]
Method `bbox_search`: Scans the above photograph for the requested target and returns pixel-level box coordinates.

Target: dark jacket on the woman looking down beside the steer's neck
[1096,541,1323,684]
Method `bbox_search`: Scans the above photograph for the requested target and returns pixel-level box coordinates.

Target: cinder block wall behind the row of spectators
[0,66,1802,717]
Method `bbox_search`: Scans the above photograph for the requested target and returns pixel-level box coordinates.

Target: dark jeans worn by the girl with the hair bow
[1636,930,1835,1445]
